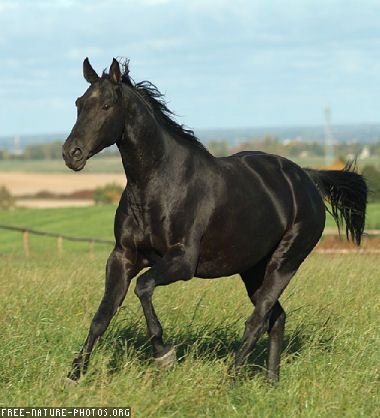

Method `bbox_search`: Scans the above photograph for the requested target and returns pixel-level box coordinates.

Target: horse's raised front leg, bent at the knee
[135,244,198,367]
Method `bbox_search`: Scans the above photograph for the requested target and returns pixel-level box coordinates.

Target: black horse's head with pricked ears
[62,58,124,171]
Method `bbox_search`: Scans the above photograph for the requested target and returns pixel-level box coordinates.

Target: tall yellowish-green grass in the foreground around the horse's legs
[0,251,380,418]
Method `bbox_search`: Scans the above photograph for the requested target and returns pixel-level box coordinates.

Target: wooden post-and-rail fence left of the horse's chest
[0,225,115,257]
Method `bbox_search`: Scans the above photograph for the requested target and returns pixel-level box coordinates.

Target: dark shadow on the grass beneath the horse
[99,323,304,376]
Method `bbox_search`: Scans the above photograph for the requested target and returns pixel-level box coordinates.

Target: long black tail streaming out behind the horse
[305,162,367,245]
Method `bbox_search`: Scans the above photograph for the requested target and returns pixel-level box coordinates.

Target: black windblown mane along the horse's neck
[103,59,208,153]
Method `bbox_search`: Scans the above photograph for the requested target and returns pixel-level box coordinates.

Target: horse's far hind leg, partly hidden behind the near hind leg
[241,257,286,380]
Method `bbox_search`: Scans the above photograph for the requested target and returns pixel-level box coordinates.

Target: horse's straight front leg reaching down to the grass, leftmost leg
[67,248,141,380]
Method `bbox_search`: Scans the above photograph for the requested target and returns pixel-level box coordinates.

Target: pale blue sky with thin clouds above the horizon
[0,0,380,136]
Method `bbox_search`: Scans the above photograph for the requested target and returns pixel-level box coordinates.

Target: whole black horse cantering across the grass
[63,58,367,380]
